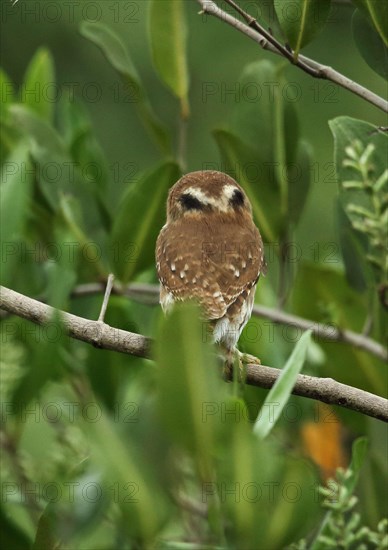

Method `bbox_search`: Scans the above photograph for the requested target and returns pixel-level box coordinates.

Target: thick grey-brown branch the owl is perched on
[0,287,388,422]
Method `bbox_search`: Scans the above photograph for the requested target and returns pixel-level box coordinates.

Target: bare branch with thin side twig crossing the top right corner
[197,0,388,113]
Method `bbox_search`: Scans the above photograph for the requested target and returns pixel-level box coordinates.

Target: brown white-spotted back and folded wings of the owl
[156,220,264,319]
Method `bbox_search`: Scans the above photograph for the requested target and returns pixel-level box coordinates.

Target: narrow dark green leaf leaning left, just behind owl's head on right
[213,130,280,242]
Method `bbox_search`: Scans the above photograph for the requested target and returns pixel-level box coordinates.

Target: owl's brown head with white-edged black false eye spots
[167,170,252,221]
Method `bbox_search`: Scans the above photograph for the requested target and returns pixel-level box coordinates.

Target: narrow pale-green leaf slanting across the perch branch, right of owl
[253,330,311,439]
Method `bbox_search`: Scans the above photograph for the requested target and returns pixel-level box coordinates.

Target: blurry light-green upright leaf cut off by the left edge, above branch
[0,144,33,283]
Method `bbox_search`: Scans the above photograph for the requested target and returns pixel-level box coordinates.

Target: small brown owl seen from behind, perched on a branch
[156,170,265,362]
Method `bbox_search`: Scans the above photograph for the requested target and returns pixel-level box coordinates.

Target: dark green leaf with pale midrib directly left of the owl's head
[109,162,180,282]
